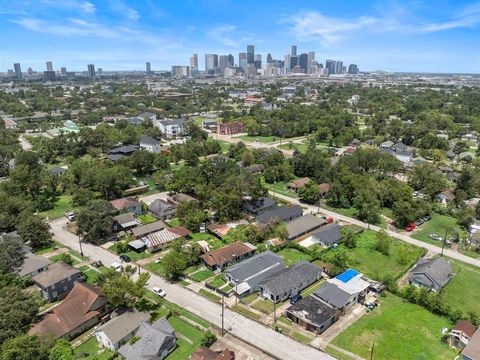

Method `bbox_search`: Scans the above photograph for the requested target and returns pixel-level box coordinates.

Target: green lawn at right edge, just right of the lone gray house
[441,259,480,315]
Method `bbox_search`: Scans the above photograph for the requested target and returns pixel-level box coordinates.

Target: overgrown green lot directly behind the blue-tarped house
[323,230,424,280]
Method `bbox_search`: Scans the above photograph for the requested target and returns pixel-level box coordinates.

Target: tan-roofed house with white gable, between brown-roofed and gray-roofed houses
[95,309,150,351]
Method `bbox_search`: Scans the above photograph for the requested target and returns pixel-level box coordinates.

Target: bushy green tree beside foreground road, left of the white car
[98,267,150,308]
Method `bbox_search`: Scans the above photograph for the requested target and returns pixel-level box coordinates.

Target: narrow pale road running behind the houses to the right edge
[269,191,480,267]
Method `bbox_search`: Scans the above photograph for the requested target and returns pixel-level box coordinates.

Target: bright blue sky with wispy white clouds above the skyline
[0,0,480,73]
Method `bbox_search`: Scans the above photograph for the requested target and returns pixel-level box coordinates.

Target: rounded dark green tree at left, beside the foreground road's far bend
[17,213,52,249]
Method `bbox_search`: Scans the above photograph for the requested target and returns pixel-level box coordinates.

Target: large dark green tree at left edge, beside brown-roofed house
[0,285,41,344]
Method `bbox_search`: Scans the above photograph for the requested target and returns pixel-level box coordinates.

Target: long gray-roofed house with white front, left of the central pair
[224,250,285,296]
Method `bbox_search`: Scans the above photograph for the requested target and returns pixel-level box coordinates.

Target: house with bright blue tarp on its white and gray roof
[314,269,370,312]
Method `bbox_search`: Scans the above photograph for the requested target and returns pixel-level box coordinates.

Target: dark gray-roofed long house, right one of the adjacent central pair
[257,261,322,303]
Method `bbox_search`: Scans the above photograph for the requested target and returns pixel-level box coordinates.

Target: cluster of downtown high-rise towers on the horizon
[171,45,359,77]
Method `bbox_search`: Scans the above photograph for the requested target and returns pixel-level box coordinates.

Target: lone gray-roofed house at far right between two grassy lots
[409,257,452,292]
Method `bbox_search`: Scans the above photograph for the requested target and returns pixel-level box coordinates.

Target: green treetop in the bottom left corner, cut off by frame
[0,335,49,360]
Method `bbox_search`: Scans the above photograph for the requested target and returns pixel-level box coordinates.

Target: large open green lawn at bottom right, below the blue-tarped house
[333,293,456,360]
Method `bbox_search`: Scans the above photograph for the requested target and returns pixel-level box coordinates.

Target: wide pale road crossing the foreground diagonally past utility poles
[50,218,335,360]
